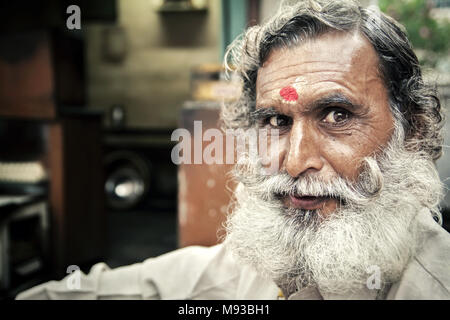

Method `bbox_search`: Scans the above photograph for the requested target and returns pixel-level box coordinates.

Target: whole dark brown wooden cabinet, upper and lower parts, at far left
[0,29,106,278]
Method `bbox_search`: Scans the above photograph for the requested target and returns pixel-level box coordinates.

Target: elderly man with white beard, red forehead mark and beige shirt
[18,1,450,299]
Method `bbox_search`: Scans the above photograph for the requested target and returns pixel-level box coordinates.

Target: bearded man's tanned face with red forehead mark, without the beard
[256,32,394,215]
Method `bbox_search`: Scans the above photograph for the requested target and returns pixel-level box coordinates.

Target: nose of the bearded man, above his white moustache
[284,121,324,178]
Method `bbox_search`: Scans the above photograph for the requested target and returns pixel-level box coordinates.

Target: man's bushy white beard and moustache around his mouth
[225,126,442,294]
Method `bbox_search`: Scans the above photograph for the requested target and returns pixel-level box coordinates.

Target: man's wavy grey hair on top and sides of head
[221,0,443,160]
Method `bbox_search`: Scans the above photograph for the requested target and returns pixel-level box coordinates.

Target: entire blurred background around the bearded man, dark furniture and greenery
[0,0,450,298]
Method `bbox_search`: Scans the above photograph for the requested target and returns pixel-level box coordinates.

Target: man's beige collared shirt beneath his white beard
[17,210,450,300]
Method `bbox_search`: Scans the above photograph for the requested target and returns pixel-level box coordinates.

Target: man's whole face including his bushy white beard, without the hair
[226,33,441,294]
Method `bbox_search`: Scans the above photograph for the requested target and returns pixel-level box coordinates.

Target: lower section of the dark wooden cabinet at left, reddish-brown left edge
[48,115,106,274]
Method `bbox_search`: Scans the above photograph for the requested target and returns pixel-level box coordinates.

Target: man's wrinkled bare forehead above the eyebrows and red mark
[256,32,384,107]
